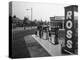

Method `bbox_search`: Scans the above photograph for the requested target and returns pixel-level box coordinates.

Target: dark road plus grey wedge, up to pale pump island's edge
[12,29,50,58]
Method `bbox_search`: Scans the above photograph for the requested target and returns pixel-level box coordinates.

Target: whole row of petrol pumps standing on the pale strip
[36,25,59,44]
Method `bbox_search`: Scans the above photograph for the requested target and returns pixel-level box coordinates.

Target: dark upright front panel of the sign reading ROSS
[64,6,75,54]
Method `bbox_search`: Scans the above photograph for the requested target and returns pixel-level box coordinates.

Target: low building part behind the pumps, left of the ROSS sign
[50,16,64,29]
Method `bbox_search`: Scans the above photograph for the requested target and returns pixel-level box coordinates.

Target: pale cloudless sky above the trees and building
[12,1,69,21]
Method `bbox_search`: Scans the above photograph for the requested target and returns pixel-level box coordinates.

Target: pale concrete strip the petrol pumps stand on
[32,35,62,56]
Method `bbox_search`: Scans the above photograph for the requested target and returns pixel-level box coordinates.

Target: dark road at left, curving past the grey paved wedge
[12,29,35,58]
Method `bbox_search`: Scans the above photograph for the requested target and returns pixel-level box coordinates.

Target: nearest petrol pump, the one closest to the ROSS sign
[49,26,59,45]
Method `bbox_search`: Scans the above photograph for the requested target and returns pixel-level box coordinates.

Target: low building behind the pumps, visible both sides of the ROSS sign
[50,16,78,29]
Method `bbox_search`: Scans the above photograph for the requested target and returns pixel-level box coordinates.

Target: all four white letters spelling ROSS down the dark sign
[66,11,73,48]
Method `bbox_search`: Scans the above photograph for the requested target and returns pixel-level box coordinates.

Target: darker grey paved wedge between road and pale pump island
[24,35,51,57]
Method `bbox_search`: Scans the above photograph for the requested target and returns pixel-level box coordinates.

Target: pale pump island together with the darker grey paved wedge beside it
[24,34,63,57]
